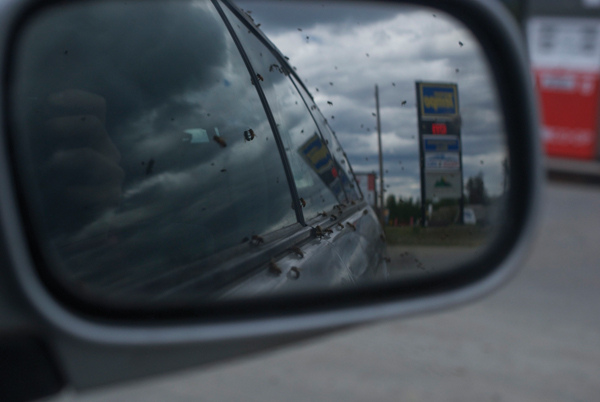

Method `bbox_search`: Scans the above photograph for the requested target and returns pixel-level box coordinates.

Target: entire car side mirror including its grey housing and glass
[0,0,541,399]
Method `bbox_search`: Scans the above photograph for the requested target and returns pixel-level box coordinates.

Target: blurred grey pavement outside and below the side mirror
[57,185,600,402]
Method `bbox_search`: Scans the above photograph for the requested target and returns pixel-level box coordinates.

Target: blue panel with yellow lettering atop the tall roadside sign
[420,82,458,117]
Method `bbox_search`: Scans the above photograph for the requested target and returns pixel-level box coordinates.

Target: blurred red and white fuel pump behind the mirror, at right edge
[527,17,600,159]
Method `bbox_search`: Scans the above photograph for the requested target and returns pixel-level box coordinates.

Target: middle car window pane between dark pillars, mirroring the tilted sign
[223,6,345,219]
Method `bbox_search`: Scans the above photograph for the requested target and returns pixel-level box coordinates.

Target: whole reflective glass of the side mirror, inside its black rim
[9,0,510,306]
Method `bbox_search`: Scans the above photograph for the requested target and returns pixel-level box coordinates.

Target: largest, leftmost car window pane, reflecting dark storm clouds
[12,1,298,293]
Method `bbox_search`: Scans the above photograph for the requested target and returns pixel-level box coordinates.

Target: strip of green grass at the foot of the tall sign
[383,225,489,247]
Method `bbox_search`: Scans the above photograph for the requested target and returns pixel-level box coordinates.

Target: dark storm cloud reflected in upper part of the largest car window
[16,3,226,129]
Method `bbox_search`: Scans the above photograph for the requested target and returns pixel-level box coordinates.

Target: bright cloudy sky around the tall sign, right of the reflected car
[236,1,507,198]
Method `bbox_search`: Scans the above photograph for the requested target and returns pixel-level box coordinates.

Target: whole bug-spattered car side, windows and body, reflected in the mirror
[13,2,386,304]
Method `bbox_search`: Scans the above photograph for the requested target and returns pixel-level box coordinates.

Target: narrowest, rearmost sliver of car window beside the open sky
[292,77,360,201]
